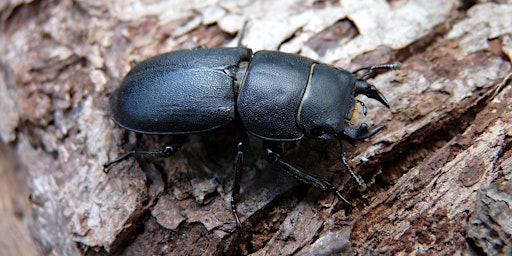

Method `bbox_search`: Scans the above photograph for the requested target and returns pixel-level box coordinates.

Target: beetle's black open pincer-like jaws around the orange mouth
[341,78,389,140]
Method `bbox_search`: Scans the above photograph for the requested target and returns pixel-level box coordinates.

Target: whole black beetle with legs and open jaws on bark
[104,46,398,227]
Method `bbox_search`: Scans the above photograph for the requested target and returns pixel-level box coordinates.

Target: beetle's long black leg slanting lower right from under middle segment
[266,144,352,205]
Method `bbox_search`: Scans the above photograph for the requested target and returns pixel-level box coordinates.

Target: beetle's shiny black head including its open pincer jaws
[297,64,389,140]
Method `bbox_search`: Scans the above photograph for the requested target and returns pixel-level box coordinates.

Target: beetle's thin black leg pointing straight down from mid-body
[231,133,247,228]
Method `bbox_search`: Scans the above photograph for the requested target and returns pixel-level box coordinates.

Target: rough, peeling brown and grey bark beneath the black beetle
[0,0,512,255]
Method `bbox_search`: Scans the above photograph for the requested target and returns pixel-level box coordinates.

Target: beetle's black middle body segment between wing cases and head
[237,51,314,141]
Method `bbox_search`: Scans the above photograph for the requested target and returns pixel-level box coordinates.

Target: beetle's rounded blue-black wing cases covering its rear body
[110,47,252,134]
